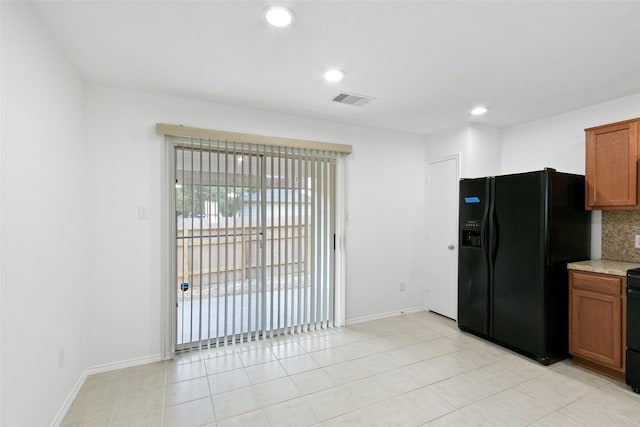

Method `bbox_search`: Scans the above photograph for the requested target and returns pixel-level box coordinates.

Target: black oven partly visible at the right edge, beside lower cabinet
[626,268,640,393]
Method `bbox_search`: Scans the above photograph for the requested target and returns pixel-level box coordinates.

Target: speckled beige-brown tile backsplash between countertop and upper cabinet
[602,211,640,262]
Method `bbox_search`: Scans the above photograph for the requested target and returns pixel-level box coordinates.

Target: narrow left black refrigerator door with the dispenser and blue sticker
[458,178,490,336]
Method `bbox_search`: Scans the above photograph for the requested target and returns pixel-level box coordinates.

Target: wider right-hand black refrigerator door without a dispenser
[492,172,547,356]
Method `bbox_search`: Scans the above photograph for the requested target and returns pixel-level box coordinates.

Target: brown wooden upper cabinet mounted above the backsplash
[585,119,640,210]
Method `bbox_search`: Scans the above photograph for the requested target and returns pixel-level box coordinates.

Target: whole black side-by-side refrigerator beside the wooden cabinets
[458,169,591,365]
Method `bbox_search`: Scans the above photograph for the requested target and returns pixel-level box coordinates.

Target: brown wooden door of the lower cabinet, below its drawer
[569,288,622,369]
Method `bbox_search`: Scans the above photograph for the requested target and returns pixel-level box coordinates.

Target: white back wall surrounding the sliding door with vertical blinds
[86,85,424,366]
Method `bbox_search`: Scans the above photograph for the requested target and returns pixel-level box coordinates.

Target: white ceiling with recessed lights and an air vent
[36,0,640,134]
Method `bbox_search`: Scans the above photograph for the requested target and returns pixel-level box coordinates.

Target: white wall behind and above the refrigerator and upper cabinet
[502,94,640,259]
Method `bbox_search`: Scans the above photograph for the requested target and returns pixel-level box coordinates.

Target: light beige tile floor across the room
[62,312,640,427]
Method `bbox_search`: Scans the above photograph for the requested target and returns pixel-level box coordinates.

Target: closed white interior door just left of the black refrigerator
[427,155,460,319]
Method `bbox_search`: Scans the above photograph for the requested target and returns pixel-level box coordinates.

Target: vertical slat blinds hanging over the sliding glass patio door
[167,136,339,350]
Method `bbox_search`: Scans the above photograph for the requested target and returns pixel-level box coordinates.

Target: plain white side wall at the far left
[0,2,88,426]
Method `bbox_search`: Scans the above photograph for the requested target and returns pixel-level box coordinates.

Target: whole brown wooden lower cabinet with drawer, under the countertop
[569,270,626,379]
